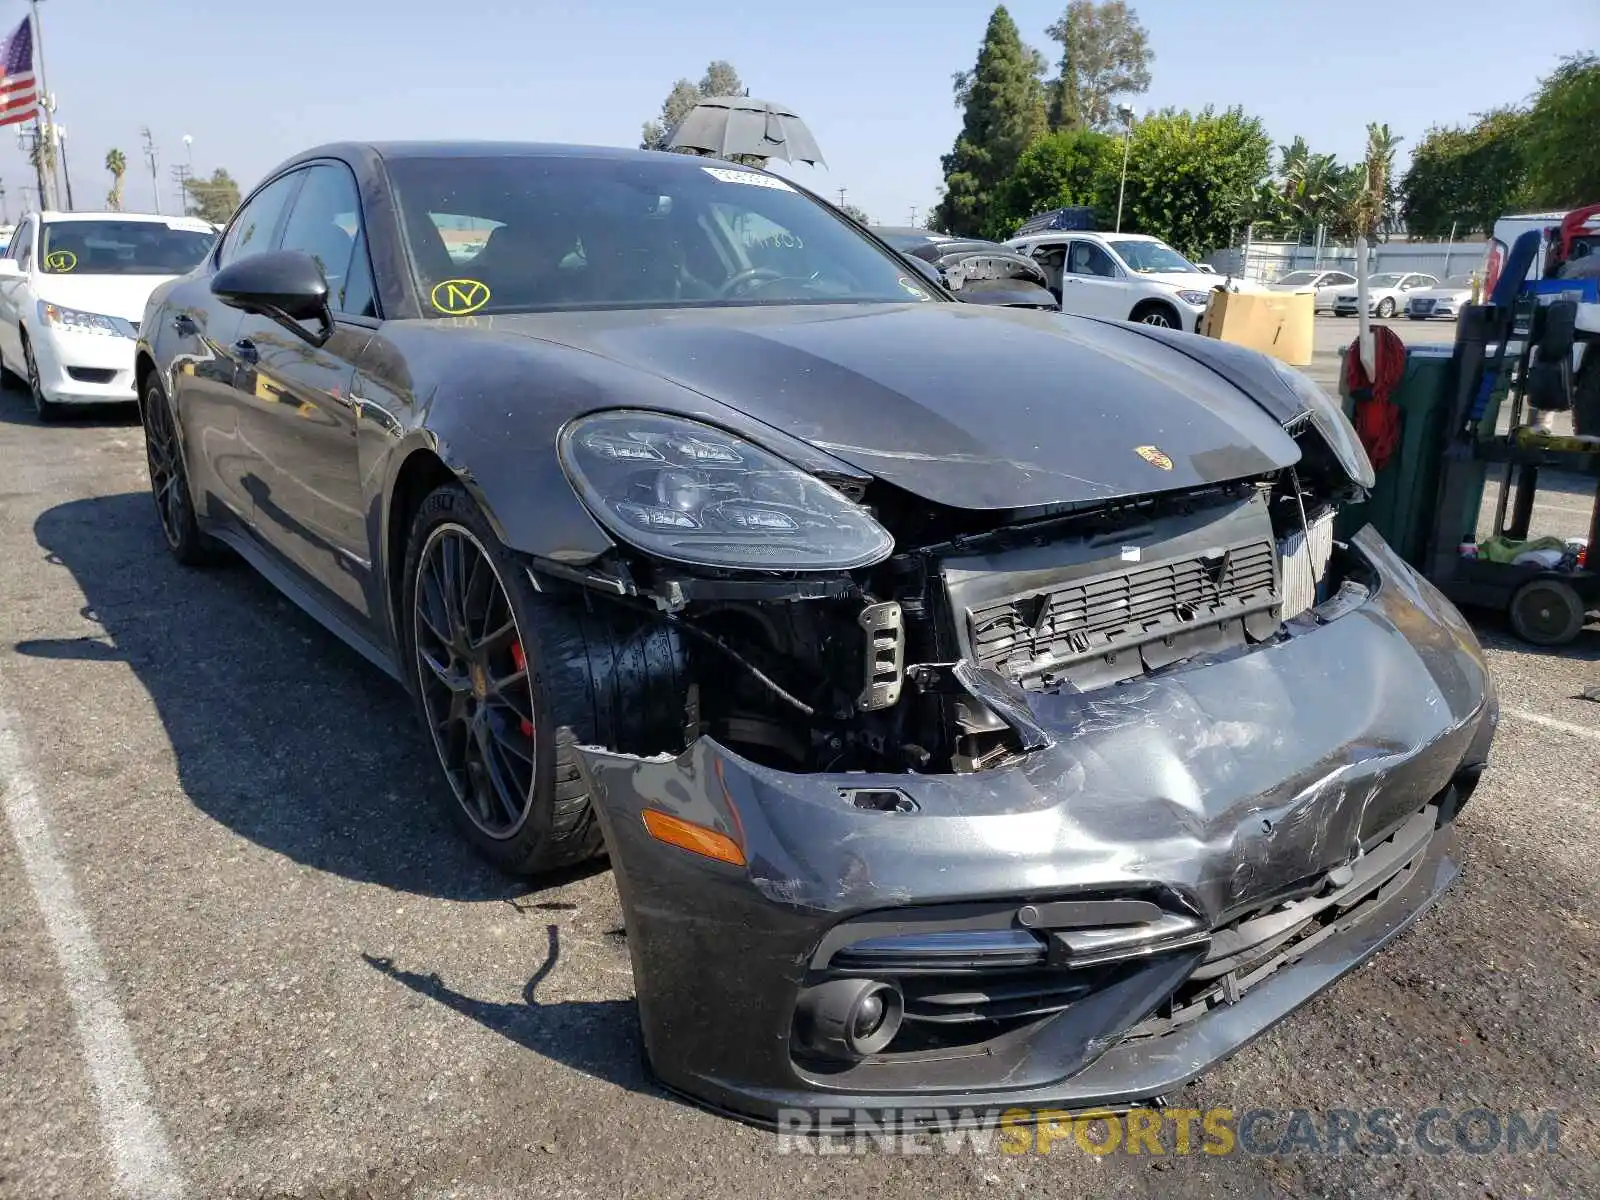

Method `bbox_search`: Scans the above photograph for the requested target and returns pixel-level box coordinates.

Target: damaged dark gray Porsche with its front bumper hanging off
[138,144,1498,1122]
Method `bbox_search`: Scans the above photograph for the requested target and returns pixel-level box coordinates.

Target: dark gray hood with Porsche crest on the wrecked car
[480,302,1299,509]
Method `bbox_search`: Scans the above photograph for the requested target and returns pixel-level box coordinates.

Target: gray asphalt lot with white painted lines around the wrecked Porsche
[0,320,1600,1200]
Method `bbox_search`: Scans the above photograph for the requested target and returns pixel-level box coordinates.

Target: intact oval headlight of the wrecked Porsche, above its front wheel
[558,411,894,571]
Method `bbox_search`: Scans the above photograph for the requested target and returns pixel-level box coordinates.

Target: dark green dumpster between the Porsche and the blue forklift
[1334,346,1504,568]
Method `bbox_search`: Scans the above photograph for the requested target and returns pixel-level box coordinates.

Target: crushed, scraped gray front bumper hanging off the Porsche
[581,530,1498,1123]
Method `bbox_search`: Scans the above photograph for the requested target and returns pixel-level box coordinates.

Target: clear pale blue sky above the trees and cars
[0,0,1600,224]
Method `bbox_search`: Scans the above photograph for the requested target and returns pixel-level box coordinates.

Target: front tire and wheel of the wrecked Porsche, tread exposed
[398,483,686,877]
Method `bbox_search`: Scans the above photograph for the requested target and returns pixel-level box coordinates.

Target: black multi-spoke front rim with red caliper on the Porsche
[411,522,539,840]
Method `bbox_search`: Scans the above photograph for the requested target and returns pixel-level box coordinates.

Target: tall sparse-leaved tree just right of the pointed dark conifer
[1045,0,1155,130]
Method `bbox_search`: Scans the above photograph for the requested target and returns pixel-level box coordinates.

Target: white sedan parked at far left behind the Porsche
[0,213,216,421]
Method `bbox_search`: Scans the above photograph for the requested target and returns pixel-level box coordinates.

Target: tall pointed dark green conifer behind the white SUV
[930,5,1045,235]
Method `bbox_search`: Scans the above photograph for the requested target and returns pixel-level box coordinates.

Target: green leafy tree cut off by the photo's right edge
[1526,53,1600,208]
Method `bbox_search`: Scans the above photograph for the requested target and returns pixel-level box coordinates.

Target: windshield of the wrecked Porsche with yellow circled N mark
[387,155,938,317]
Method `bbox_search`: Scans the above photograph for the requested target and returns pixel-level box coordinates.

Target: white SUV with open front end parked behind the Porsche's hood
[1006,229,1221,333]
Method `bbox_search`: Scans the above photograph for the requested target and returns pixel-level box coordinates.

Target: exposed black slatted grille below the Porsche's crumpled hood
[966,541,1277,680]
